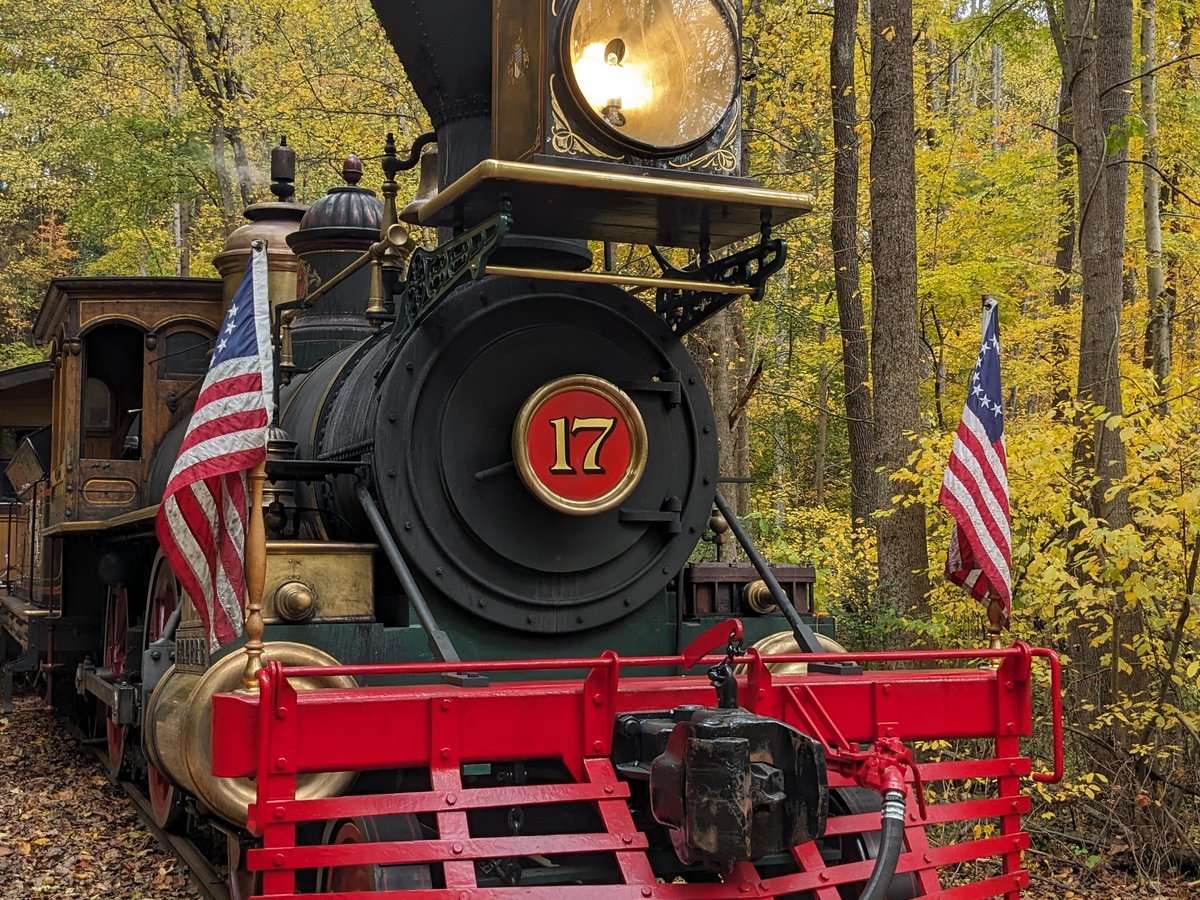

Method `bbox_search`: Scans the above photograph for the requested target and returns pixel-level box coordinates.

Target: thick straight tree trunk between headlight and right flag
[870,0,929,624]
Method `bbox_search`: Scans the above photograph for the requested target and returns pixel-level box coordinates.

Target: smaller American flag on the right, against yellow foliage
[940,300,1013,622]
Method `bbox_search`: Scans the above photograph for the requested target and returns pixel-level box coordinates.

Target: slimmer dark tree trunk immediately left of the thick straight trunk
[829,0,878,522]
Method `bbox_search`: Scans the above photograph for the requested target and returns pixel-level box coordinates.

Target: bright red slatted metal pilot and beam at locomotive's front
[212,644,1062,900]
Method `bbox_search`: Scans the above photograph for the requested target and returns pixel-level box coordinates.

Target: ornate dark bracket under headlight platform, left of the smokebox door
[396,210,512,337]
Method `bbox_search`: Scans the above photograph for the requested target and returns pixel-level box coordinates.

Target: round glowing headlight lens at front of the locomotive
[563,0,738,152]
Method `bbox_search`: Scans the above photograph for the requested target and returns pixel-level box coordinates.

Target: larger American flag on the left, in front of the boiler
[156,247,274,652]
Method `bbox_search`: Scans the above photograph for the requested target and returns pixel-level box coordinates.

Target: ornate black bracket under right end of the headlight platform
[650,227,787,336]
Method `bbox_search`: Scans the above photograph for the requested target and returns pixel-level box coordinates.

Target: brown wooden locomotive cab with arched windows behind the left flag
[34,278,224,528]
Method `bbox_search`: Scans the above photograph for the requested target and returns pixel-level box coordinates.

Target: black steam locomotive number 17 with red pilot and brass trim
[0,0,1061,900]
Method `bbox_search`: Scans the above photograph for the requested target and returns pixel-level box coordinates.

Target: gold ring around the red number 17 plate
[512,374,648,516]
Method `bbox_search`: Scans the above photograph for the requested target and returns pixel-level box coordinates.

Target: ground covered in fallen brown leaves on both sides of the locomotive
[0,694,1200,900]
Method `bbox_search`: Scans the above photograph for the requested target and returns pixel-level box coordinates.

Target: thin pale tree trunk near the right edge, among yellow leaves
[1141,0,1171,415]
